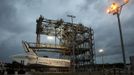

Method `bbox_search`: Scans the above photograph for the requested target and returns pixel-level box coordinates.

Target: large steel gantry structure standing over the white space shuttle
[26,16,94,72]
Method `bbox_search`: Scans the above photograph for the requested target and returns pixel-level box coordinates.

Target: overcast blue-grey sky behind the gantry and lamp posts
[0,0,134,63]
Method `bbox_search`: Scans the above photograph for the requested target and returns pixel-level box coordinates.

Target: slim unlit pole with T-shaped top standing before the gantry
[67,15,76,72]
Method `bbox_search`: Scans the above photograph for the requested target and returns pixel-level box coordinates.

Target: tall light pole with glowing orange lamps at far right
[107,0,129,69]
